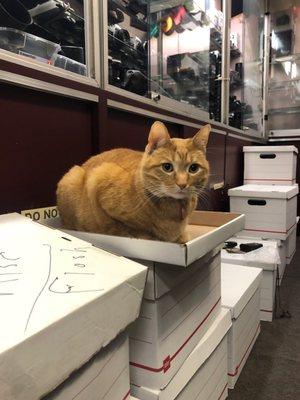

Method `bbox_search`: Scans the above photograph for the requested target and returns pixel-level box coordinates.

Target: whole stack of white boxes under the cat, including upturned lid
[48,212,244,400]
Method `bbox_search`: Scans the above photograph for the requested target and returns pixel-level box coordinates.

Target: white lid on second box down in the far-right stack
[228,184,299,199]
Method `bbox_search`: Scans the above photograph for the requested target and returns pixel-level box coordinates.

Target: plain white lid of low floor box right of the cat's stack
[221,263,263,319]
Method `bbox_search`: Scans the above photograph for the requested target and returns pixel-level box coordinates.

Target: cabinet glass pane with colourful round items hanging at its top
[149,0,223,121]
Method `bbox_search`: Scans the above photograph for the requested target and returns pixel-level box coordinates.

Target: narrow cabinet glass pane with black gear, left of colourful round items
[108,0,150,97]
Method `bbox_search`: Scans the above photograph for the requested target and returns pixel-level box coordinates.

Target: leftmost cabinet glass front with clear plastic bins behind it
[0,0,93,77]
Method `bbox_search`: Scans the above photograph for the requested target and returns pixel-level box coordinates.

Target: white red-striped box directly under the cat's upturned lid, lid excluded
[130,252,221,390]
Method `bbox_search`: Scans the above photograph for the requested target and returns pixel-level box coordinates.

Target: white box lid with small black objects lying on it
[221,237,281,271]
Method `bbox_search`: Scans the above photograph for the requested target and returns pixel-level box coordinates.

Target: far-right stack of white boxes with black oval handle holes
[228,146,299,280]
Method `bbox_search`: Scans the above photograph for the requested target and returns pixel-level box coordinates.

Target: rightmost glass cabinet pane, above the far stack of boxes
[268,0,300,131]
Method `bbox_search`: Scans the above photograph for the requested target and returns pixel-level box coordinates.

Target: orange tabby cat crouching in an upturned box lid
[57,122,211,243]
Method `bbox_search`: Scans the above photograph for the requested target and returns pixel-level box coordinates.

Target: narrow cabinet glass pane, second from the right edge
[229,0,265,136]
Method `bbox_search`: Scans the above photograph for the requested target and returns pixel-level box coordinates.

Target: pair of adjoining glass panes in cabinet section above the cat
[107,0,223,121]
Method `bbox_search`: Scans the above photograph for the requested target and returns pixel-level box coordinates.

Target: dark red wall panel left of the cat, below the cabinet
[0,84,95,213]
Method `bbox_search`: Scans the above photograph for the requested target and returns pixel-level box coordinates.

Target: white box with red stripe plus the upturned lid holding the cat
[46,211,244,390]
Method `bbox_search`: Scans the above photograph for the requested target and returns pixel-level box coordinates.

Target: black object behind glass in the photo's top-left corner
[0,0,32,30]
